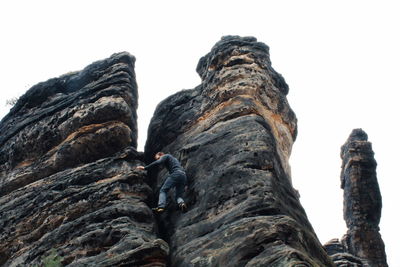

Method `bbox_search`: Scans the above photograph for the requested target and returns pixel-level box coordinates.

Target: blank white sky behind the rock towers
[0,0,400,266]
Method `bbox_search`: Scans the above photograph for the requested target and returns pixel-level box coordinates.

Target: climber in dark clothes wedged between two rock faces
[136,152,187,213]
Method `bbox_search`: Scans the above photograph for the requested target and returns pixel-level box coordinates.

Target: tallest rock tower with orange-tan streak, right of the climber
[145,36,333,266]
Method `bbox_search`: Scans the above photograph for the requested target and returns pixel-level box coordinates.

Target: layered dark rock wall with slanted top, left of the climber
[0,53,169,266]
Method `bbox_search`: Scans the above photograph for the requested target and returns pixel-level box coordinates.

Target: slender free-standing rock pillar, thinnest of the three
[334,129,388,266]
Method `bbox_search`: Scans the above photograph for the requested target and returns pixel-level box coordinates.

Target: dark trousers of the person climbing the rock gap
[158,171,186,208]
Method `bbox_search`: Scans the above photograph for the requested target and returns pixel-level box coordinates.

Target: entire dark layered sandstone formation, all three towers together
[0,36,387,267]
